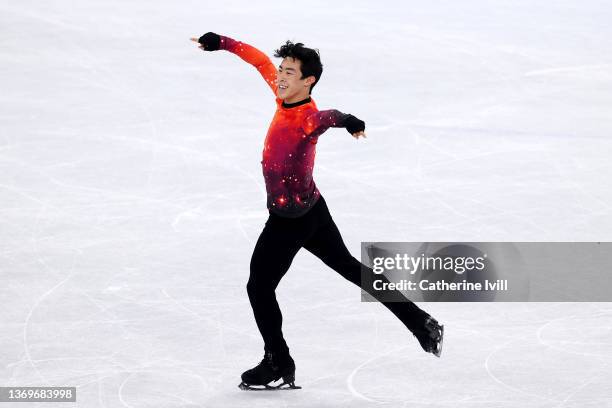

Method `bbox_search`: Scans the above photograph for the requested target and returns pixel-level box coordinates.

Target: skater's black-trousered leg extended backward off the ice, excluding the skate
[304,198,429,337]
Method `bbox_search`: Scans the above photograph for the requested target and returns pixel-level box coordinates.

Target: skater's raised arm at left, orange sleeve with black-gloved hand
[191,32,276,96]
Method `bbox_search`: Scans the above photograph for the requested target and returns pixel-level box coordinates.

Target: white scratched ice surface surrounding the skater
[0,0,612,408]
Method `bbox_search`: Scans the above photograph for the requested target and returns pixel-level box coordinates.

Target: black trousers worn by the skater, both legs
[247,196,429,353]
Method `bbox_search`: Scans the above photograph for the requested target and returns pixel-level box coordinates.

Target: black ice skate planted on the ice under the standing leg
[238,351,302,391]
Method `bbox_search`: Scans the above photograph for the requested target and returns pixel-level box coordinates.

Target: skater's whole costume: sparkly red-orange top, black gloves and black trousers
[200,33,429,367]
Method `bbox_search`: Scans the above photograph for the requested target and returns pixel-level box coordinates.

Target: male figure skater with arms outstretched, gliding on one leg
[191,32,443,389]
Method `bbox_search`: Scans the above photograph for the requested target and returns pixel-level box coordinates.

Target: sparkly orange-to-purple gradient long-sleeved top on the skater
[220,36,348,218]
